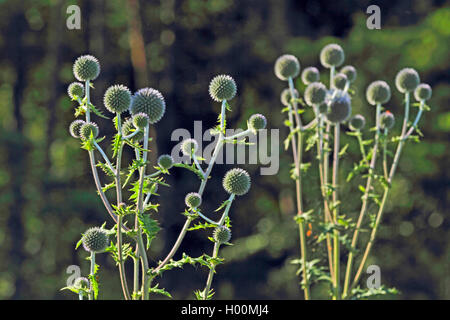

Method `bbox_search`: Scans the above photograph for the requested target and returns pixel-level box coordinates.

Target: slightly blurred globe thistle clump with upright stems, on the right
[272,44,431,300]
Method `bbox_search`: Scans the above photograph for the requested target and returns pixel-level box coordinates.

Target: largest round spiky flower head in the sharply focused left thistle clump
[130,88,166,124]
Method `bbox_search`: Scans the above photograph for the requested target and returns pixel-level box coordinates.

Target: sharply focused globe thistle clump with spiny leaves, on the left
[64,55,267,300]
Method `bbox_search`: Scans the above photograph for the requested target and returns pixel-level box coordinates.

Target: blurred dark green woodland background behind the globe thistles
[0,0,450,299]
